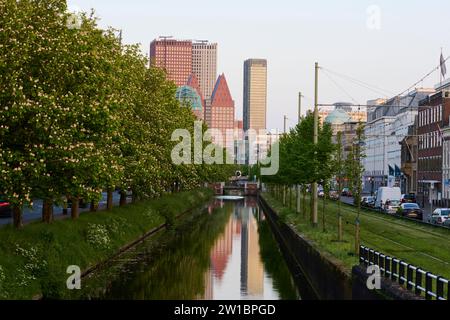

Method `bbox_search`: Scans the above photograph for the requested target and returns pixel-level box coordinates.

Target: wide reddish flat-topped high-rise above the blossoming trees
[150,38,192,87]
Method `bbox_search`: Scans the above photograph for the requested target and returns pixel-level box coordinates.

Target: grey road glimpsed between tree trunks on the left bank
[0,192,127,226]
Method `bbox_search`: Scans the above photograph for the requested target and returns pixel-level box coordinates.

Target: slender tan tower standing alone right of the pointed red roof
[244,59,267,131]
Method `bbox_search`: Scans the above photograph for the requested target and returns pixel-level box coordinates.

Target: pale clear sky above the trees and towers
[68,0,450,129]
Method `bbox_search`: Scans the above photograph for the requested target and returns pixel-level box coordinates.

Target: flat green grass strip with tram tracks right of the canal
[264,193,450,278]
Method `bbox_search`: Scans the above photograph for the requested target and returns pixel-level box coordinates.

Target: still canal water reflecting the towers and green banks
[82,197,306,300]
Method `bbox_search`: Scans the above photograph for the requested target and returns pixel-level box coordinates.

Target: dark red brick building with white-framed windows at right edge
[417,91,450,206]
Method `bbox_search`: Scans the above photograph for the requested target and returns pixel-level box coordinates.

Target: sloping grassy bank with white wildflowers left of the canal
[0,189,212,299]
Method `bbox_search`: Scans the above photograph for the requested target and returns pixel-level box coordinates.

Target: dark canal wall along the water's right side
[259,196,417,300]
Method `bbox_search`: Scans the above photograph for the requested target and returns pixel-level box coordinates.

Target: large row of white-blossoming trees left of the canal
[0,0,233,227]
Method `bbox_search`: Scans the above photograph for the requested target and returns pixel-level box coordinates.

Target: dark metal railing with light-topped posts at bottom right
[359,246,450,300]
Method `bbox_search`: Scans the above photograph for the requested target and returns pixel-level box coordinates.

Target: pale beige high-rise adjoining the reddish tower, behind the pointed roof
[192,41,217,99]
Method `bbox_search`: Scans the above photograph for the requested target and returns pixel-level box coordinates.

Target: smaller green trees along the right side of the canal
[261,113,364,238]
